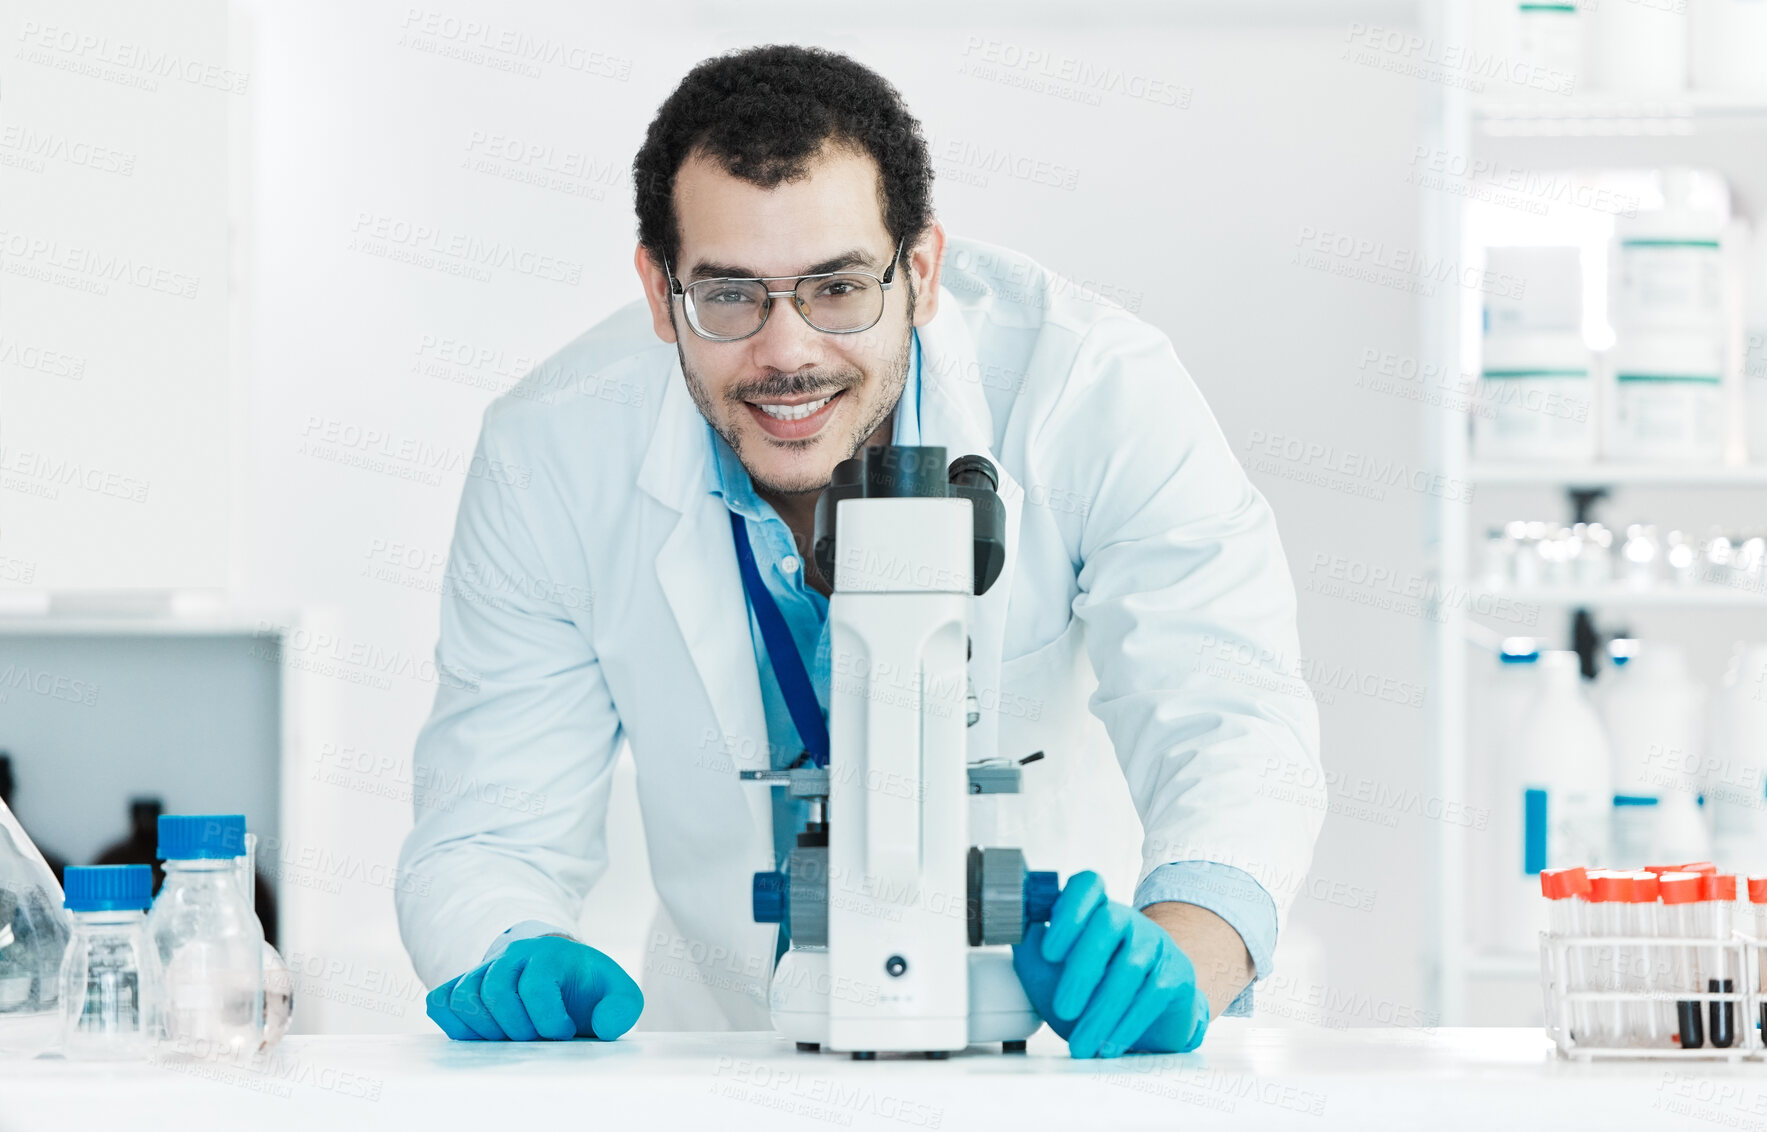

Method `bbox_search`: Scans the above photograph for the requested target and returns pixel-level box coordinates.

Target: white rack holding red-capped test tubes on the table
[1541,932,1767,1061]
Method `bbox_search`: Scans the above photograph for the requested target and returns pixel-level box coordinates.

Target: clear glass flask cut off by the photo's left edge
[0,802,67,1058]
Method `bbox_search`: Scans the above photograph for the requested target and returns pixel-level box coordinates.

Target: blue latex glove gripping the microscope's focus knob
[1012,872,1209,1058]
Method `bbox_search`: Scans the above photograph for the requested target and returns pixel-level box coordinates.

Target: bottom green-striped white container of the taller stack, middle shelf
[1603,328,1726,464]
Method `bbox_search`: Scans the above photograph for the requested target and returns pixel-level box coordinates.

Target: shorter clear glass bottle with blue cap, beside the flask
[60,865,161,1060]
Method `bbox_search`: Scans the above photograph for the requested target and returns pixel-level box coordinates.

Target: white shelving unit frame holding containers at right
[1417,0,1767,1026]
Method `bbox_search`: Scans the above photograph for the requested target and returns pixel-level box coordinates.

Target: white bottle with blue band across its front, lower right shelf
[1596,643,1710,869]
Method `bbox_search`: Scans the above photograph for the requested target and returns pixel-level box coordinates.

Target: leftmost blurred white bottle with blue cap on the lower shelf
[1467,638,1539,950]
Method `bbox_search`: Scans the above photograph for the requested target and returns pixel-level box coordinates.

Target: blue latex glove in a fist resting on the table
[424,936,645,1042]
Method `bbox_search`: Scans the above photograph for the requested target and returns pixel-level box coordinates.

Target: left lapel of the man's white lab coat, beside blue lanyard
[638,374,772,844]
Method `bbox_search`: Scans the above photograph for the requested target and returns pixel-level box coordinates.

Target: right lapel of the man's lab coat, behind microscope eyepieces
[921,300,1025,761]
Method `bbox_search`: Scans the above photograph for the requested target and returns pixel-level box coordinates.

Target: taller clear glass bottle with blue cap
[147,814,263,1056]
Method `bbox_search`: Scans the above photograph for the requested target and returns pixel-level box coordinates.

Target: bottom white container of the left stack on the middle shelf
[1472,330,1597,463]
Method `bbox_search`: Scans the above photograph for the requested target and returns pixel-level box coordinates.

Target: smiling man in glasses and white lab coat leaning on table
[398,46,1323,1056]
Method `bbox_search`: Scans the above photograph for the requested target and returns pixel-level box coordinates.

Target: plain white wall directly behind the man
[13,0,1433,1031]
